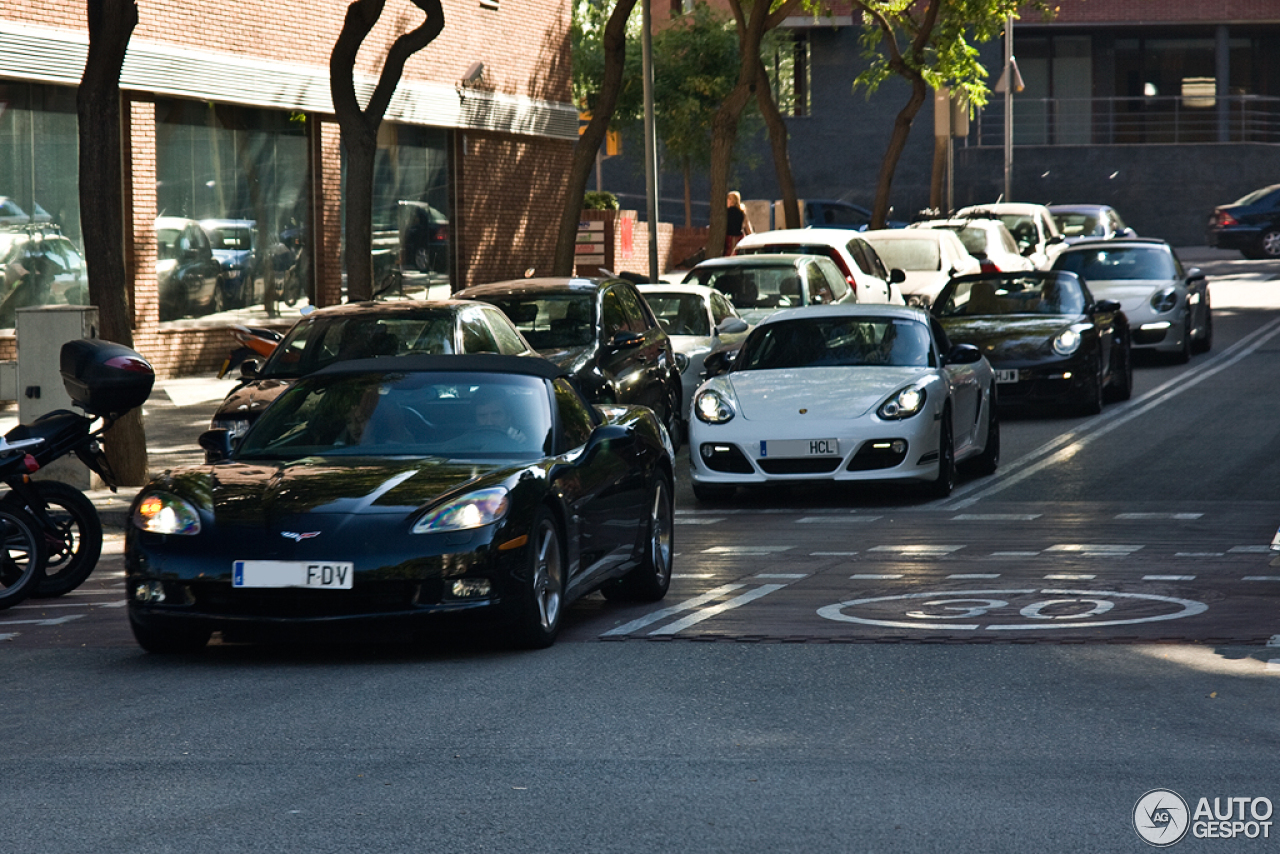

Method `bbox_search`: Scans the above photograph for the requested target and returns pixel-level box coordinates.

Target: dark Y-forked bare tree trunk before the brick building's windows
[329,0,444,302]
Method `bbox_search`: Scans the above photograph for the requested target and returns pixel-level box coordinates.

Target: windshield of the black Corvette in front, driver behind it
[236,371,553,460]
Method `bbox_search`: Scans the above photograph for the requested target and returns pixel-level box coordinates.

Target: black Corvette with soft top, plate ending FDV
[125,355,673,652]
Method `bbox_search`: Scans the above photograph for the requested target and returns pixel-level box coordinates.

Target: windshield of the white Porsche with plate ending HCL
[733,318,934,370]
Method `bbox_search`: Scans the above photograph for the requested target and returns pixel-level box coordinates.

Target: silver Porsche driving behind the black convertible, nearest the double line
[1053,237,1213,362]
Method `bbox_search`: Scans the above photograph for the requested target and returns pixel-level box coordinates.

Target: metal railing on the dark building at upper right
[969,95,1280,147]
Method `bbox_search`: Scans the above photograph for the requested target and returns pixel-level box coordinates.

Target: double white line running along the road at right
[940,320,1280,510]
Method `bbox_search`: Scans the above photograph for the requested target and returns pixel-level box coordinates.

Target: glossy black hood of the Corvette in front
[162,457,512,529]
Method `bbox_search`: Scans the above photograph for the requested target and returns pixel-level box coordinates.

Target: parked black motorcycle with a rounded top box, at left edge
[0,339,155,607]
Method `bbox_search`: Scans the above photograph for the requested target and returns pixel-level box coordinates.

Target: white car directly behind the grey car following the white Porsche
[733,228,905,305]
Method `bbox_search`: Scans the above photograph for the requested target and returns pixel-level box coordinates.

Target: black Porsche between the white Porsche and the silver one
[931,270,1133,415]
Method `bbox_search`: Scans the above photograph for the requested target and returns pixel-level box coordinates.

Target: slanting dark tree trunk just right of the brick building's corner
[552,0,636,275]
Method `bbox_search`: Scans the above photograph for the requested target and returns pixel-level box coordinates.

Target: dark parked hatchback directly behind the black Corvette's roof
[454,278,684,440]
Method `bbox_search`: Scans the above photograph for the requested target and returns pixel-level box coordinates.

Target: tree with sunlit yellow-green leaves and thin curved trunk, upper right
[854,0,1047,228]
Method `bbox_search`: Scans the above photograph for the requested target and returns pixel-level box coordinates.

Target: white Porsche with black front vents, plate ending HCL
[689,305,1000,501]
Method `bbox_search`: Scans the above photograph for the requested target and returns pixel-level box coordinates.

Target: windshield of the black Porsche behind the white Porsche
[936,273,1084,318]
